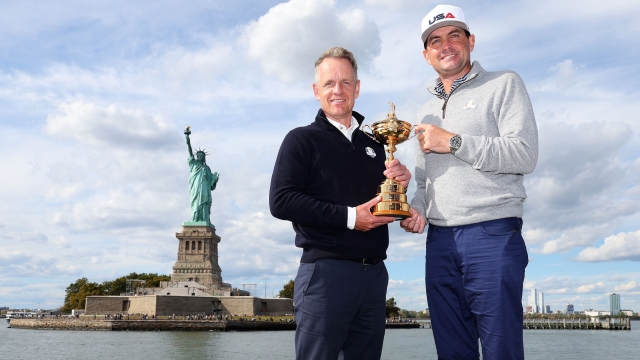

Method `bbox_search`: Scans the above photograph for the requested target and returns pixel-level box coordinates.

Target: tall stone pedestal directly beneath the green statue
[171,224,222,288]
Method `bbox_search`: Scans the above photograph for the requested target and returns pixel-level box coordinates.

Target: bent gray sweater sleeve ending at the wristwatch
[455,72,538,174]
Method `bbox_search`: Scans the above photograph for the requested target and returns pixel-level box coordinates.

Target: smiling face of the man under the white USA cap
[422,26,476,79]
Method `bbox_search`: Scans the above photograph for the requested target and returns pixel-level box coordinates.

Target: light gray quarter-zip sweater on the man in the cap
[411,61,538,226]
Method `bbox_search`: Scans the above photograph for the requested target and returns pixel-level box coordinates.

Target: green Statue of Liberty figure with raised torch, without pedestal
[184,126,220,227]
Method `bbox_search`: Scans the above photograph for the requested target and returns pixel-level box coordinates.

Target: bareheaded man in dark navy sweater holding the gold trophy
[269,47,411,359]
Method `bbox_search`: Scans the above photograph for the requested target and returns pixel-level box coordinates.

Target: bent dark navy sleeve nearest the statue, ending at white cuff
[269,130,347,228]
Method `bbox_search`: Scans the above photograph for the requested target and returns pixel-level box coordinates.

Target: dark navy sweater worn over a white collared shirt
[269,109,389,263]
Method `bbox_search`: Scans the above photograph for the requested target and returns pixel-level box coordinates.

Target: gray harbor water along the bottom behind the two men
[0,319,640,360]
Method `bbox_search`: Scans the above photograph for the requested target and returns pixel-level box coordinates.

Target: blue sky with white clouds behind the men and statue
[0,0,640,311]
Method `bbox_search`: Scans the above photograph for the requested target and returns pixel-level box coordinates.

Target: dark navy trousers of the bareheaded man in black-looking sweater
[293,259,389,360]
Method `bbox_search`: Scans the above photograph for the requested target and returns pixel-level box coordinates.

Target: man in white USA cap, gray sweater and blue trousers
[401,5,538,360]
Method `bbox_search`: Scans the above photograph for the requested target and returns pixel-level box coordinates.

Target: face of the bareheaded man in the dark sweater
[313,57,360,127]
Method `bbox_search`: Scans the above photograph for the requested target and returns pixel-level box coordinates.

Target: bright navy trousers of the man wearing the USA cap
[425,218,529,360]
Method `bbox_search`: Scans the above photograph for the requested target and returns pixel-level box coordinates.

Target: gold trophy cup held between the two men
[360,101,414,219]
